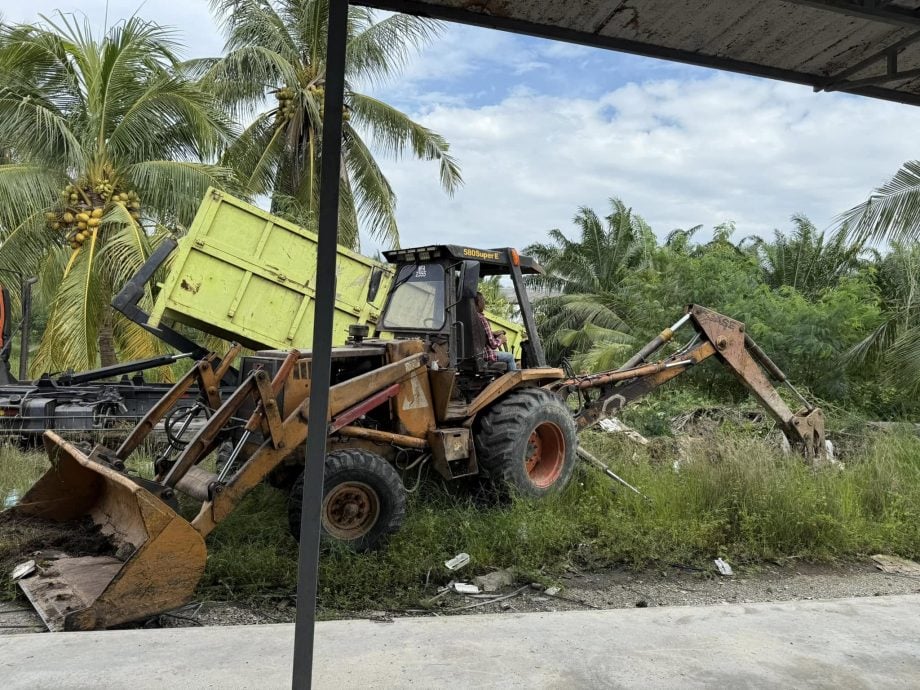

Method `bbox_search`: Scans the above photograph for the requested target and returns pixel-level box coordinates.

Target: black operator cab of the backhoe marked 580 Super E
[378,245,545,388]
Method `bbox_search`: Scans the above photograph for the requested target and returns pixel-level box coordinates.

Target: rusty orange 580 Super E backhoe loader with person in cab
[6,245,824,630]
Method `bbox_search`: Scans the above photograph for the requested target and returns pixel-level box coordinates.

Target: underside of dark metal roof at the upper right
[358,0,920,105]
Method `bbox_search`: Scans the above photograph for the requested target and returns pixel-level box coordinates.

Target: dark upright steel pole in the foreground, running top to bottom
[291,0,348,690]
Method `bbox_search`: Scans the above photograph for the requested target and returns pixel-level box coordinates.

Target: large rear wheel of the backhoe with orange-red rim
[476,388,576,498]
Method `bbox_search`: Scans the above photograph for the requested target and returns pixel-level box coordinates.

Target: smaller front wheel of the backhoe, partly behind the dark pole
[288,449,406,551]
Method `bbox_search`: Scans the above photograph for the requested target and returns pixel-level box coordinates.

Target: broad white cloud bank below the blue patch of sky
[372,73,920,246]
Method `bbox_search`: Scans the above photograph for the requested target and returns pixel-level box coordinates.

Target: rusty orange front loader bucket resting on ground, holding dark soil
[3,431,206,630]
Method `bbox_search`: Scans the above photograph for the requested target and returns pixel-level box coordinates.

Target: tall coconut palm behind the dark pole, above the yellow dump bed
[199,0,461,248]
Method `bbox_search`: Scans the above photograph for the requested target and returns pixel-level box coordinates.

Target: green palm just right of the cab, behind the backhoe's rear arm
[525,199,657,369]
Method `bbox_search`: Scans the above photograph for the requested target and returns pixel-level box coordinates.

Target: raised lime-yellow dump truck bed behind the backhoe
[148,189,523,354]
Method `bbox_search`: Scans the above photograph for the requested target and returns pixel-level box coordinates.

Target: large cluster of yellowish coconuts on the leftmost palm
[45,179,141,249]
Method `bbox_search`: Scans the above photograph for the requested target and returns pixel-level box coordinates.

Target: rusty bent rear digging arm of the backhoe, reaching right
[552,305,825,458]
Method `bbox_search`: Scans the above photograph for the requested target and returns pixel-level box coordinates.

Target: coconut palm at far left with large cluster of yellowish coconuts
[0,14,231,370]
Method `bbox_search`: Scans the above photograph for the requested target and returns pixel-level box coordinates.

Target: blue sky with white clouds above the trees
[2,0,920,251]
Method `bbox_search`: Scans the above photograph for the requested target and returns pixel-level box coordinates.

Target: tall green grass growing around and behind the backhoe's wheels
[0,432,920,615]
